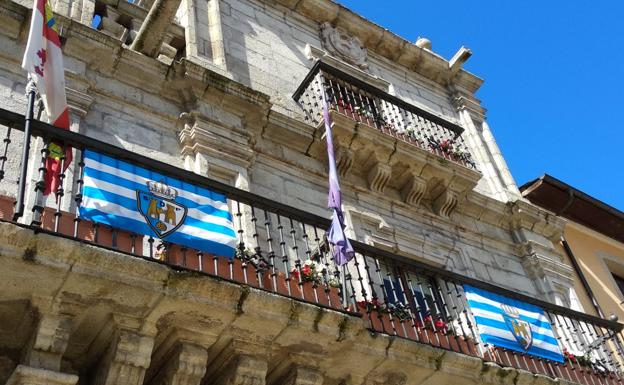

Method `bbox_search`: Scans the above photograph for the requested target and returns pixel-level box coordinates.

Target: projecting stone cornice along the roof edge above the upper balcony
[264,0,483,93]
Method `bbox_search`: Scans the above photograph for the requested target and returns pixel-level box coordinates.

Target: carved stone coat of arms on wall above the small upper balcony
[321,22,368,69]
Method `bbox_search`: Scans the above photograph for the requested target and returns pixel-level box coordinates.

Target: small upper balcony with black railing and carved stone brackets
[293,61,482,217]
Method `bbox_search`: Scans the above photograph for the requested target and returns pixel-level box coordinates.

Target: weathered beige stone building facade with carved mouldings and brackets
[0,0,607,385]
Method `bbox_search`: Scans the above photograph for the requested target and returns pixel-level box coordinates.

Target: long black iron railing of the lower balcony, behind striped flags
[0,109,624,385]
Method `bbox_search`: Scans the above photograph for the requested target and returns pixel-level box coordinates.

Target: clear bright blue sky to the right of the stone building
[339,0,624,211]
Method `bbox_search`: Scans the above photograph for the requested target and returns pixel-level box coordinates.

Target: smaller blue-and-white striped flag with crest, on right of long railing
[464,285,563,362]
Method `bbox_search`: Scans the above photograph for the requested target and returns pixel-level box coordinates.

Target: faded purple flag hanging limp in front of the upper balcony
[322,92,355,266]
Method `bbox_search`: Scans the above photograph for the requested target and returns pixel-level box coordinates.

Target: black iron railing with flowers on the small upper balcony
[293,61,476,169]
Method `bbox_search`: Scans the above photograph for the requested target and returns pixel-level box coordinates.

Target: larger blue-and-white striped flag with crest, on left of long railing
[79,150,236,258]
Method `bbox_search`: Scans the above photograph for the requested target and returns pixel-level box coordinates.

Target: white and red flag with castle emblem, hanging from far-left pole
[22,0,72,195]
